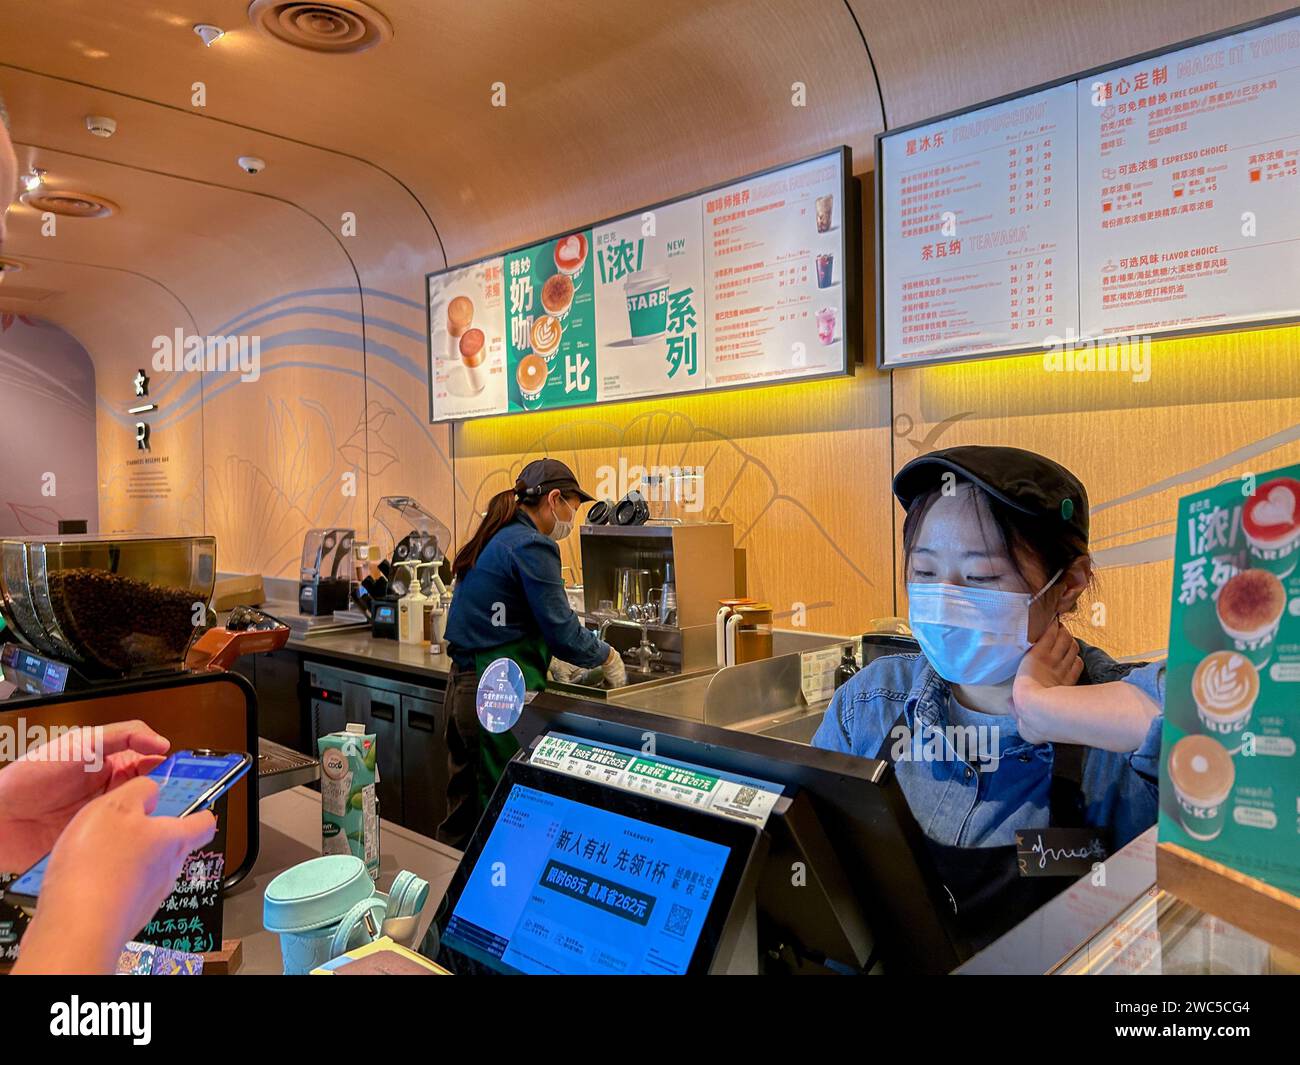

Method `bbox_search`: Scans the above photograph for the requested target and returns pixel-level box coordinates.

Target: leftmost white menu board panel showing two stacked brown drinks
[429,259,506,417]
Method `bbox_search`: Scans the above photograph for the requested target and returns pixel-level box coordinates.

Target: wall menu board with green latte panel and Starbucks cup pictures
[426,147,858,421]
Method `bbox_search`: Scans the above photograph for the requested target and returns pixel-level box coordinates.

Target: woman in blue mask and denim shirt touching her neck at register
[813,446,1164,948]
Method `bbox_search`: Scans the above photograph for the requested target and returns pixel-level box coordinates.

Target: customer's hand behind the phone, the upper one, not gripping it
[0,722,170,873]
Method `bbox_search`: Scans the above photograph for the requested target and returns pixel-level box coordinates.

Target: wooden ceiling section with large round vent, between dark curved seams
[0,0,880,269]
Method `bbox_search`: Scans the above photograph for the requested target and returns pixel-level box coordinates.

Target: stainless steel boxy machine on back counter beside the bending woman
[579,520,736,684]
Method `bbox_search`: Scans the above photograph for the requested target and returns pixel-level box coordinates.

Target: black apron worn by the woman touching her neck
[876,710,1087,951]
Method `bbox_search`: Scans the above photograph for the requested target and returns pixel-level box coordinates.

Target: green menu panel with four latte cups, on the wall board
[506,230,595,411]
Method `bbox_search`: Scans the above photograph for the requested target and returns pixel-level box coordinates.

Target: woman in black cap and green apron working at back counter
[438,459,628,849]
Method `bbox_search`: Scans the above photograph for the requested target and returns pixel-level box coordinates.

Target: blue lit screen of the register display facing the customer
[443,784,731,975]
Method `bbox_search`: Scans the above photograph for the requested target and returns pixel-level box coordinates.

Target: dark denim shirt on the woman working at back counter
[447,510,610,670]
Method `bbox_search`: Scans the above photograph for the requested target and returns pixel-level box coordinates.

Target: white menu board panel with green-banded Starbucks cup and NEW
[592,200,707,401]
